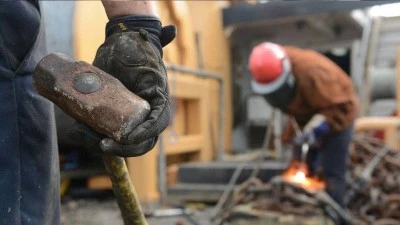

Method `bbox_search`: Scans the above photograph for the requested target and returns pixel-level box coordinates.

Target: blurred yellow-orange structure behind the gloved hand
[74,0,232,203]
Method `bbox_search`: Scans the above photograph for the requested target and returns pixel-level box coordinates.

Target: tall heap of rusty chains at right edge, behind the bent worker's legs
[347,136,400,225]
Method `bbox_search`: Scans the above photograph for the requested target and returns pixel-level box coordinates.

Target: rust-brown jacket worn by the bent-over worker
[284,47,359,131]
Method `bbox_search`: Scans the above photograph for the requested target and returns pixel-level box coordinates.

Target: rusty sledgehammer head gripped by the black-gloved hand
[33,53,150,143]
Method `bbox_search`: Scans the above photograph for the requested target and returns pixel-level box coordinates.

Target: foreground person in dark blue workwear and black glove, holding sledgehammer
[0,0,176,225]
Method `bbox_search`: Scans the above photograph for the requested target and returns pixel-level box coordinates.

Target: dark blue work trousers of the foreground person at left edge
[0,1,60,225]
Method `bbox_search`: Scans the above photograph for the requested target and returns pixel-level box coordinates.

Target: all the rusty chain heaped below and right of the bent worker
[221,136,400,225]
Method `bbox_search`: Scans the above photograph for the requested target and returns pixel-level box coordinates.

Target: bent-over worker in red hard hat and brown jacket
[249,42,359,206]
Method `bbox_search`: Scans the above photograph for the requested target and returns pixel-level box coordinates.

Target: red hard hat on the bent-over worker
[249,42,286,84]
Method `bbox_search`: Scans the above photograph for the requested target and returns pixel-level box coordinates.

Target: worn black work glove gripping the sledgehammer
[69,15,176,157]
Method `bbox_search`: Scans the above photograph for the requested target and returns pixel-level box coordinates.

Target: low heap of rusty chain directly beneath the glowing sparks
[220,176,351,224]
